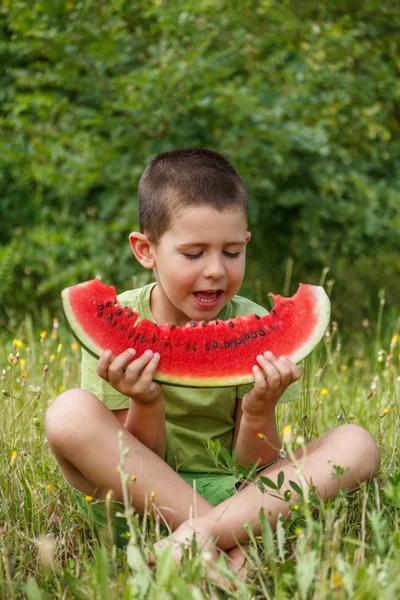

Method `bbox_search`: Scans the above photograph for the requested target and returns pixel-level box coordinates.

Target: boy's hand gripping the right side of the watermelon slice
[242,352,301,417]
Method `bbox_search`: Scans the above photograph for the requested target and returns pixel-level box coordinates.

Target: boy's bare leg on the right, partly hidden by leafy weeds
[159,425,380,560]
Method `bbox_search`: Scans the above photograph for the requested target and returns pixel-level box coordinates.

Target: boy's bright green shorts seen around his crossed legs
[75,473,240,548]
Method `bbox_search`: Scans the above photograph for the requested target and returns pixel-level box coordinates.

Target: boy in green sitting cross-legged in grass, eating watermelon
[46,148,380,561]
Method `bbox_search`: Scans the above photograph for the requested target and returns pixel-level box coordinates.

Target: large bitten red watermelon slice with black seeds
[62,279,330,387]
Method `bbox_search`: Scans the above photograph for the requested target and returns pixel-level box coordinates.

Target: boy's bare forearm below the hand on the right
[233,398,281,467]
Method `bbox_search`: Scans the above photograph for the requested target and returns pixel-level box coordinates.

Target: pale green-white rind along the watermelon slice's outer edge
[62,283,330,388]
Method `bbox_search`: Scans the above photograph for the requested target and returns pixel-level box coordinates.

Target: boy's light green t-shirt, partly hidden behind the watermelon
[81,283,300,473]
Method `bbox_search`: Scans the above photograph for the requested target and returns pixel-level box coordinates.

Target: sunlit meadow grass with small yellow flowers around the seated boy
[0,303,400,600]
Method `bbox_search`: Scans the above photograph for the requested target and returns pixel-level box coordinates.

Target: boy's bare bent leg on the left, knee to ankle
[46,389,212,530]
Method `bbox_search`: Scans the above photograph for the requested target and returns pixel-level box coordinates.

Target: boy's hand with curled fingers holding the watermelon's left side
[96,348,162,404]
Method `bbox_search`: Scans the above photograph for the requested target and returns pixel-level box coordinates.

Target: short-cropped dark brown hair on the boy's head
[139,148,248,244]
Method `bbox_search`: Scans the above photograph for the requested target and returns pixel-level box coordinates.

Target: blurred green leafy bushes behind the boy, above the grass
[0,0,400,327]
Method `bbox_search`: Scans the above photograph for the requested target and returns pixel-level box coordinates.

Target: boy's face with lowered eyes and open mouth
[151,206,251,326]
